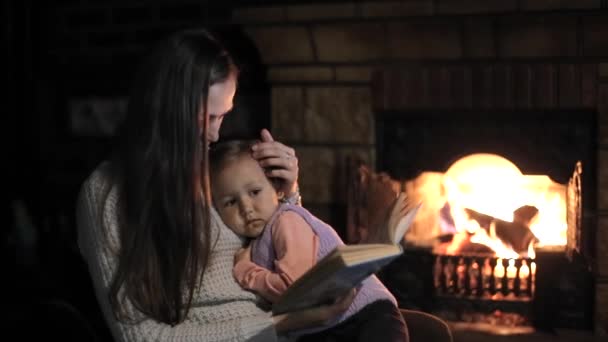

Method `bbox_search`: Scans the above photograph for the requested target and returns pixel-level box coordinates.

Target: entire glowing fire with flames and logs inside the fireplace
[405,153,568,259]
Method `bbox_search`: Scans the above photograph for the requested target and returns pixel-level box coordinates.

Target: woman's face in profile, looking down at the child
[198,76,236,144]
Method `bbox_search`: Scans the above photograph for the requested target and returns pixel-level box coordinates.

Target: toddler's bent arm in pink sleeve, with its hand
[233,211,319,303]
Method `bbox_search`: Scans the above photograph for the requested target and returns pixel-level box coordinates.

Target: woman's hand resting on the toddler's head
[253,129,299,197]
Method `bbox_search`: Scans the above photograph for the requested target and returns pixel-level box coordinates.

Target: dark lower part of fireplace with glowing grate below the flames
[378,246,592,334]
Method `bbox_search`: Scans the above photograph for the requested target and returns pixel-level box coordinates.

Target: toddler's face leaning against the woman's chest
[212,155,279,238]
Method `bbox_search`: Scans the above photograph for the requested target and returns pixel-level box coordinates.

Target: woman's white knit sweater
[77,162,277,342]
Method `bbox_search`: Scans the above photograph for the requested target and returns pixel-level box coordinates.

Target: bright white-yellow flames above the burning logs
[442,154,567,259]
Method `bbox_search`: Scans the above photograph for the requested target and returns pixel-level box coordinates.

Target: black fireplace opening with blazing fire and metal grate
[376,111,597,329]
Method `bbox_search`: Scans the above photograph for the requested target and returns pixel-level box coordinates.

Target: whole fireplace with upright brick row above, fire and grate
[346,62,598,333]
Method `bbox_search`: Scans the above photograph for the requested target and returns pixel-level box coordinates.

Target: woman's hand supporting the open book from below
[272,289,357,334]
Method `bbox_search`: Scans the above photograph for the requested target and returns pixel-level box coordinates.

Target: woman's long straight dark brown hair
[109,30,238,325]
